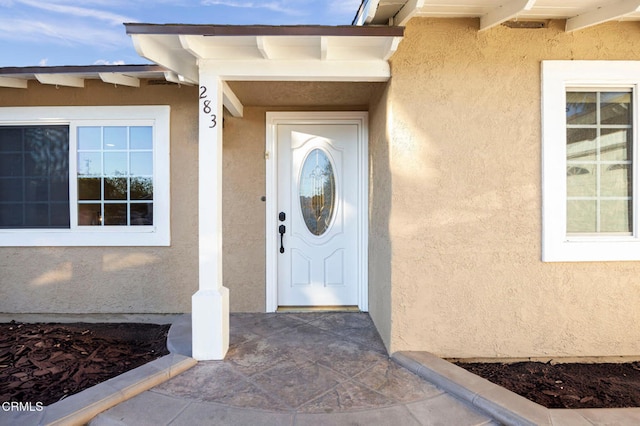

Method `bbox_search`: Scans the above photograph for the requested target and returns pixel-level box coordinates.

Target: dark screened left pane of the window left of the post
[0,126,70,228]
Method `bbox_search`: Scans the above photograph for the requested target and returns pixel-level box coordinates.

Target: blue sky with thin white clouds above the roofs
[0,0,361,67]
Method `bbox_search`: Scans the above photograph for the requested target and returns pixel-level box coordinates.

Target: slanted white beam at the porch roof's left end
[131,34,199,84]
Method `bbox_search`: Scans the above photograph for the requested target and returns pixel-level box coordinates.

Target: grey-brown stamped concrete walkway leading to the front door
[90,313,498,426]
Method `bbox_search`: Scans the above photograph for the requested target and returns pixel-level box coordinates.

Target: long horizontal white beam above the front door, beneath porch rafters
[210,59,391,82]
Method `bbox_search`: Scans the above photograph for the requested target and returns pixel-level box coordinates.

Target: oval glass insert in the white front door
[298,148,336,236]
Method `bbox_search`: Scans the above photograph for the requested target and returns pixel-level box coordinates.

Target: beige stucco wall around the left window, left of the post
[0,81,198,313]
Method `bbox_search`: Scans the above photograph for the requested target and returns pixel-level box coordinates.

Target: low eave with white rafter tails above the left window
[0,65,179,89]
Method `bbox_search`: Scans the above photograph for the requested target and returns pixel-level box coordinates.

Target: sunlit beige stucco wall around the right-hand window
[382,18,640,358]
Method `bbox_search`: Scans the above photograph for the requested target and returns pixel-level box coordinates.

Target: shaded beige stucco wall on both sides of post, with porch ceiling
[0,80,379,313]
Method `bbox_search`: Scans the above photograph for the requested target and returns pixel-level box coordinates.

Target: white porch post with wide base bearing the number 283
[192,65,229,360]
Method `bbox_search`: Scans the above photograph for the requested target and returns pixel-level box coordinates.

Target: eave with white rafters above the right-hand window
[354,0,640,31]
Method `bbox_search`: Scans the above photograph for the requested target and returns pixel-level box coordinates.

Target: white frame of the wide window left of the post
[0,105,171,247]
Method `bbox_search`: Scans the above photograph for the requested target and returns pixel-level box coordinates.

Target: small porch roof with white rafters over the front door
[125,23,403,84]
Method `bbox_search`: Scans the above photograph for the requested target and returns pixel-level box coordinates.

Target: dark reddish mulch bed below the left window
[0,322,169,405]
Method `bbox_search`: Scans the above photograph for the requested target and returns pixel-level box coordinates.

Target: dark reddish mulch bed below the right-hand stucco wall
[456,362,640,408]
